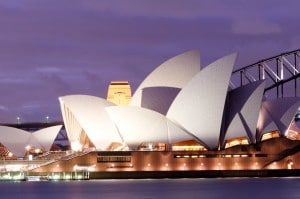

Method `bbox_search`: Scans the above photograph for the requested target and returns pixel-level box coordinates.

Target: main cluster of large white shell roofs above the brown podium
[60,50,300,151]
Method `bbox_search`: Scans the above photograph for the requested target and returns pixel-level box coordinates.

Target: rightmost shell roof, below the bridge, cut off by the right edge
[257,97,300,138]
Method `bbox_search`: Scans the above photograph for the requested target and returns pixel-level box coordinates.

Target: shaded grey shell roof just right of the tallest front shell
[222,81,265,144]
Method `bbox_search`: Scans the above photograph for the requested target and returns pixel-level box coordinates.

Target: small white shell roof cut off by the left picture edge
[0,126,31,157]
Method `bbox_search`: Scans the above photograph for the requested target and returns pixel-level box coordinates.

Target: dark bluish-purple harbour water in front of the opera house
[0,178,300,199]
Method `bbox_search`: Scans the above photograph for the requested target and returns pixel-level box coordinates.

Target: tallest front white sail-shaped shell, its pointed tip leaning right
[167,53,237,148]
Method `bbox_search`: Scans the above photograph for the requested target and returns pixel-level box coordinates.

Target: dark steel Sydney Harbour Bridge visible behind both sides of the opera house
[3,49,300,145]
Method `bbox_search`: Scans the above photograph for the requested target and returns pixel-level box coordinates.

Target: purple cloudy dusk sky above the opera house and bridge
[0,0,300,123]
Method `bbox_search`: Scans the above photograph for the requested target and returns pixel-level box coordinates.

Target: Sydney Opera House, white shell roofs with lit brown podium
[0,50,300,178]
